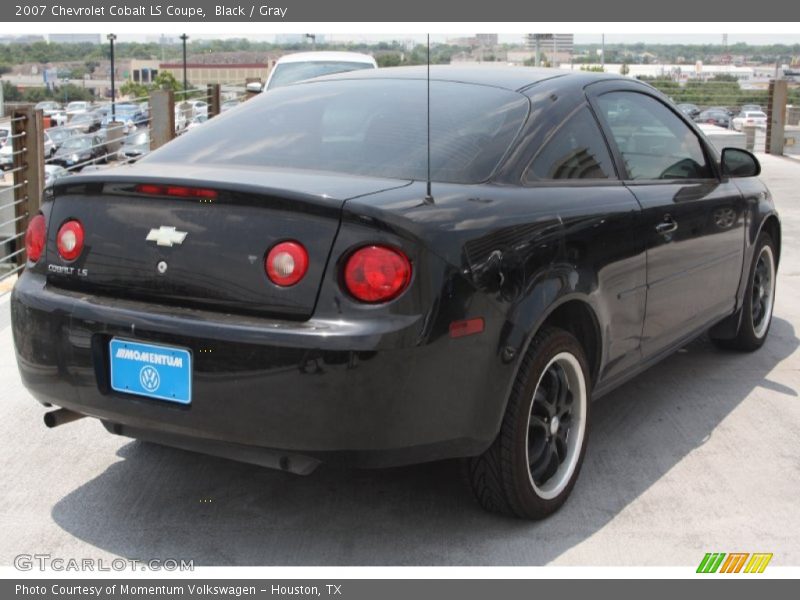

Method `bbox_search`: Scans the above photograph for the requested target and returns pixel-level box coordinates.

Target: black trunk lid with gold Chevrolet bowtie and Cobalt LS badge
[46,159,409,319]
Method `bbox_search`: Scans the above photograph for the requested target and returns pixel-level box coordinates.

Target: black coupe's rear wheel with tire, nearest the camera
[465,328,591,519]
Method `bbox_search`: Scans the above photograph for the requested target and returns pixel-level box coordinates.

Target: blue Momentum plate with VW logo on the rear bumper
[109,339,192,404]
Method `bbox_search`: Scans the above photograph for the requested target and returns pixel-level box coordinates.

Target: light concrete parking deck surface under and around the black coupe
[0,155,800,566]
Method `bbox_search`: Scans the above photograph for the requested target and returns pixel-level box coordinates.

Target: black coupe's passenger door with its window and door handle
[592,86,745,359]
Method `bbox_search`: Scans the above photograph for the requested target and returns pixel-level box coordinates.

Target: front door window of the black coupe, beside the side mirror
[597,92,714,179]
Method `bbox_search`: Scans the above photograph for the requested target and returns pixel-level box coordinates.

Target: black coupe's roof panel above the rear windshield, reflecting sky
[314,64,620,91]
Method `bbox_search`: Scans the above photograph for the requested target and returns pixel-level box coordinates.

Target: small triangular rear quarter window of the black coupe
[524,106,616,183]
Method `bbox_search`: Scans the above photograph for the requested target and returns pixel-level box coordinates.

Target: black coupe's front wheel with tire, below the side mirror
[712,233,778,352]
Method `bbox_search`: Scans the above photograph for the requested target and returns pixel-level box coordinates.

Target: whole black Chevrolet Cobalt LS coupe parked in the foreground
[11,67,781,518]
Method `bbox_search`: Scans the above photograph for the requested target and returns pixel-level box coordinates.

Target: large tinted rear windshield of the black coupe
[143,79,529,183]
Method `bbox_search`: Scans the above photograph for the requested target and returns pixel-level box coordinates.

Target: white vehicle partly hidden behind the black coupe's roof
[260,52,378,91]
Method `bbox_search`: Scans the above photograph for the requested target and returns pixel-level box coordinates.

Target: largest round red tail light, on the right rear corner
[344,246,411,303]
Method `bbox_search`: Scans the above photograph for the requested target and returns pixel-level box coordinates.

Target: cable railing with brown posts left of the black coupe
[0,85,231,293]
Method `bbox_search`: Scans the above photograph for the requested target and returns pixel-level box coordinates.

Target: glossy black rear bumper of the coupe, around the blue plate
[11,272,510,470]
